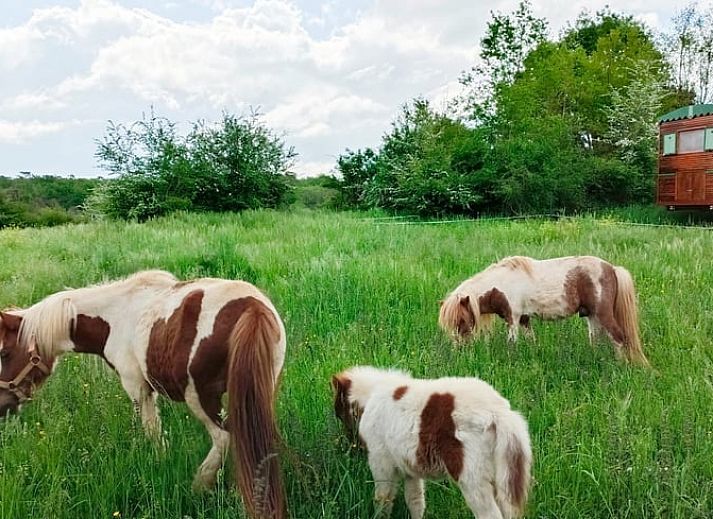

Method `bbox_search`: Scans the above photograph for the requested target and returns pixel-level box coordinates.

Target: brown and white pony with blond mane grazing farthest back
[438,256,648,365]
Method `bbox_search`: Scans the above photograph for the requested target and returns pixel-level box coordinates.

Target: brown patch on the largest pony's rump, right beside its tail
[188,297,257,425]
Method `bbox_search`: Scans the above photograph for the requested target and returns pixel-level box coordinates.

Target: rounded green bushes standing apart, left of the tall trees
[90,112,295,221]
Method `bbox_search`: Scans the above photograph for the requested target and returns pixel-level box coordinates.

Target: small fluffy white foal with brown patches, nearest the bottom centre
[332,366,532,519]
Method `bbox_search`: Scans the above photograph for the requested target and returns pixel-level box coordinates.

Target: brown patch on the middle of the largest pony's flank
[146,290,203,401]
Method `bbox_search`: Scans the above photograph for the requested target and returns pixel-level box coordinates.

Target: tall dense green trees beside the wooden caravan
[337,1,713,215]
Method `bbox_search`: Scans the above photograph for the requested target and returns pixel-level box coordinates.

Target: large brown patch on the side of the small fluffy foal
[416,393,464,481]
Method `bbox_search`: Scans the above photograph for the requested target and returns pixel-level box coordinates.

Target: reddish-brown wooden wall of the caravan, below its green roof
[656,115,713,206]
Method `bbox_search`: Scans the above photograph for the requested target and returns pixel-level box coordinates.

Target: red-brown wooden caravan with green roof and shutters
[656,104,713,210]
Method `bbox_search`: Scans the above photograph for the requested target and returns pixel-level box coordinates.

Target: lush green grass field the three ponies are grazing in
[0,212,713,519]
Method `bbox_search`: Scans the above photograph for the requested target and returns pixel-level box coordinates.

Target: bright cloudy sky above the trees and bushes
[0,0,681,177]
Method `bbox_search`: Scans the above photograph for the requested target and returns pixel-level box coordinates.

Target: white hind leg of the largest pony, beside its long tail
[186,383,230,492]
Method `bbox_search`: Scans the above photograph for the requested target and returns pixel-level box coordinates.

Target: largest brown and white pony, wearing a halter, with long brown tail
[0,271,286,518]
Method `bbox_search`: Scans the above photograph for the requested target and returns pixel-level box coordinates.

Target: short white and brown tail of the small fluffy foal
[494,411,532,518]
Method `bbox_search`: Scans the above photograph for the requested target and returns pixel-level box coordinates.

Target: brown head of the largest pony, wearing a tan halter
[0,312,50,417]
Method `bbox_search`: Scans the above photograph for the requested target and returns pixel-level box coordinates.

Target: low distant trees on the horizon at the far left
[0,174,101,227]
